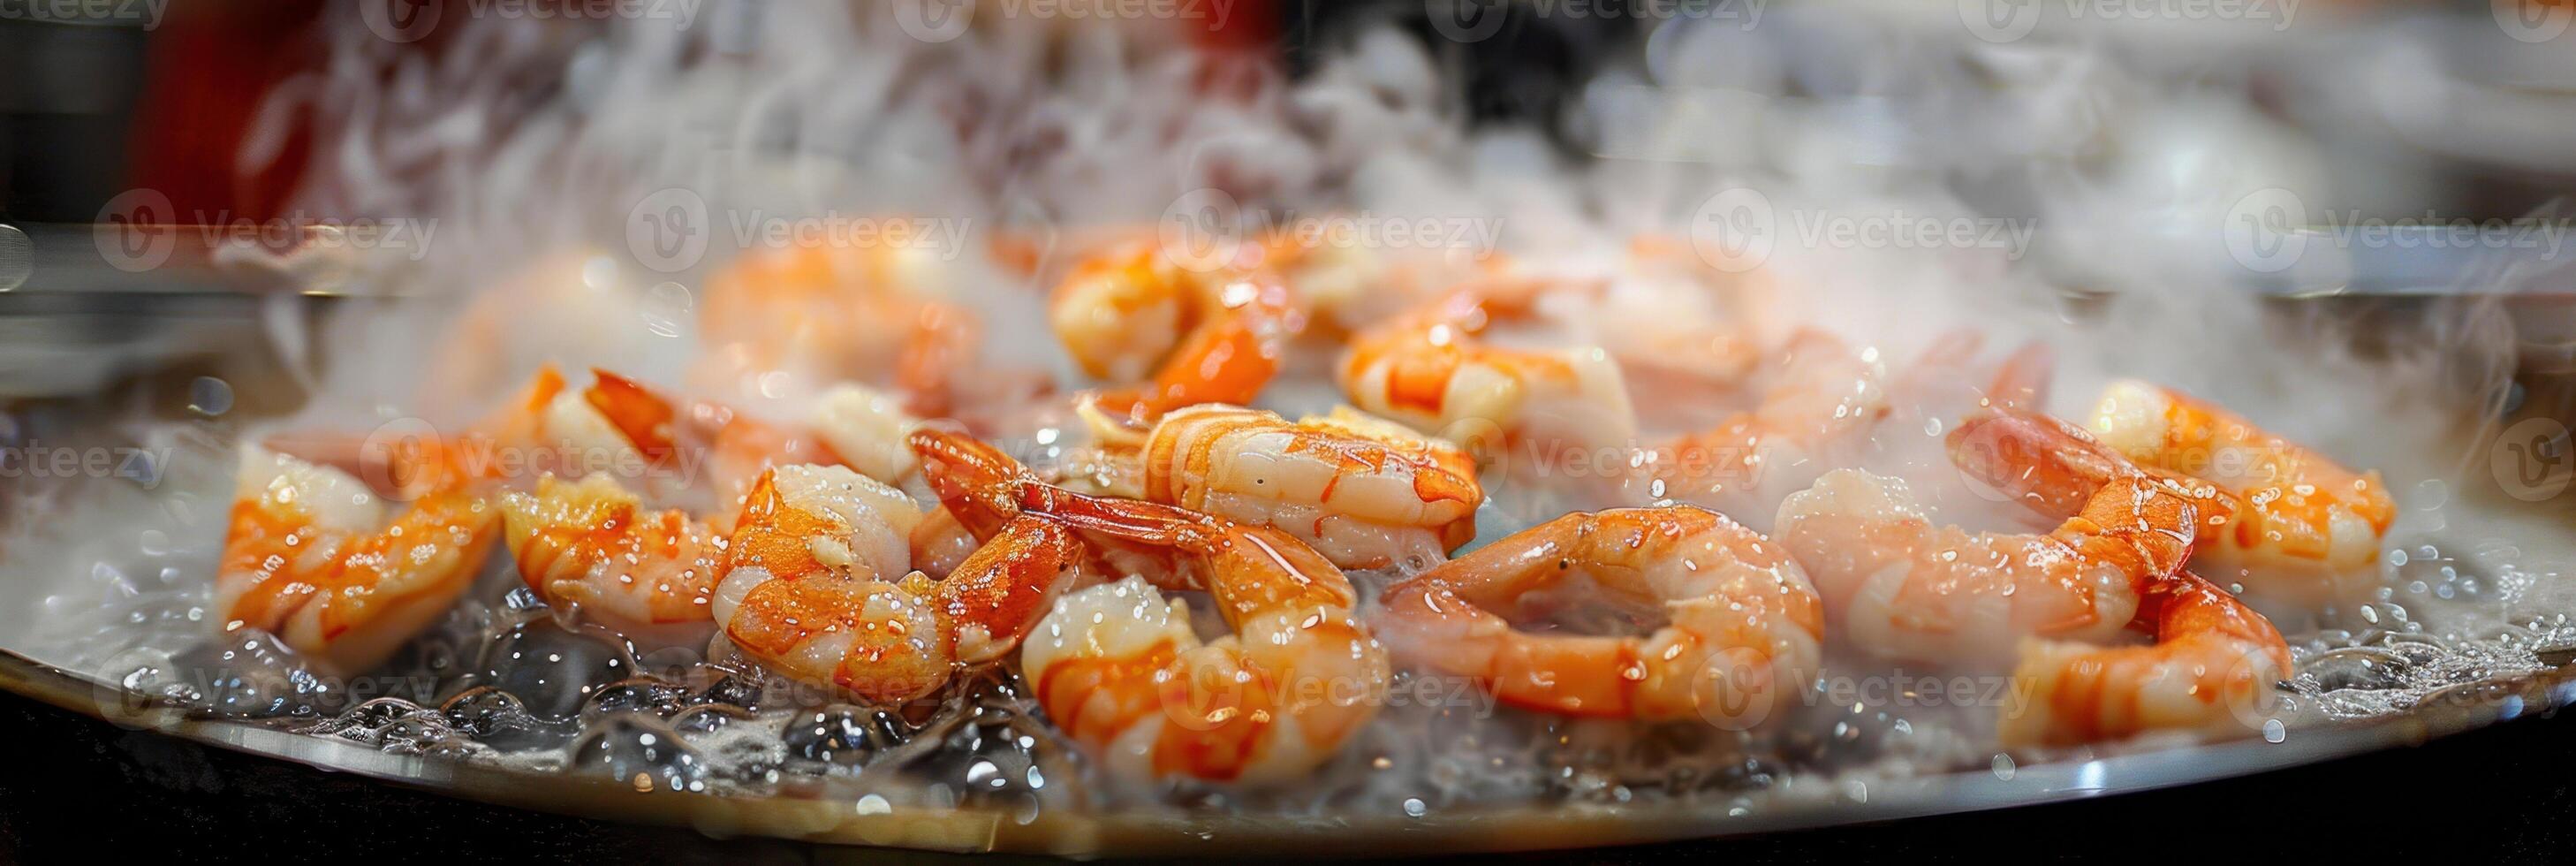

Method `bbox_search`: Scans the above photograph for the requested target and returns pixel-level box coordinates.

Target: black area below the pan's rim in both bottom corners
[0,694,2576,863]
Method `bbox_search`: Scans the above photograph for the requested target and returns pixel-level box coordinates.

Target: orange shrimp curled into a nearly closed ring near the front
[1383,505,1824,727]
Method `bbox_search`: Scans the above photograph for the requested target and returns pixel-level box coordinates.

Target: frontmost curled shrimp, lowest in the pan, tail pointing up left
[1020,495,1389,784]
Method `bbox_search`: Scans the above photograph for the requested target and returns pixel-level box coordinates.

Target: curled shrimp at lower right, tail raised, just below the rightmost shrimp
[1950,410,2290,748]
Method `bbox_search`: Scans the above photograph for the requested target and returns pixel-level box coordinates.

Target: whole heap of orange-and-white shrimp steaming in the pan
[216,225,2396,786]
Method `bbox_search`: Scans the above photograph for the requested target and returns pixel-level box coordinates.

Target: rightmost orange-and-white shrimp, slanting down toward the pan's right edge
[2092,382,2396,604]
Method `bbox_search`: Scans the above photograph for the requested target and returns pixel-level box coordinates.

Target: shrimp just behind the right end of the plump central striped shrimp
[1337,276,1636,446]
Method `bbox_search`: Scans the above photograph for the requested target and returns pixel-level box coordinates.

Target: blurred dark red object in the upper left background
[129,0,324,222]
